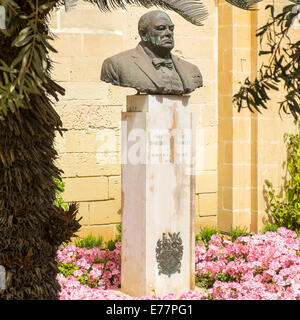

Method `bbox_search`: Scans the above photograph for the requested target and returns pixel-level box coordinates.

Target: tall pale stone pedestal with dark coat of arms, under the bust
[121,95,195,296]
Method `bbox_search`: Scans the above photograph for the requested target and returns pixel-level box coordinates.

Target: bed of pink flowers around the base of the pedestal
[57,228,300,300]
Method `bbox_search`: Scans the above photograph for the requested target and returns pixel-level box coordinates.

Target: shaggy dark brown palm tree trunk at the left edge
[0,0,80,300]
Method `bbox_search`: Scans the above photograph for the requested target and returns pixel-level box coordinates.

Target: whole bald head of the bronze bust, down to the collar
[138,10,174,57]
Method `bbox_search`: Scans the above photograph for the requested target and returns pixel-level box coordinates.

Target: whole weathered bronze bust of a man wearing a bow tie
[101,10,203,95]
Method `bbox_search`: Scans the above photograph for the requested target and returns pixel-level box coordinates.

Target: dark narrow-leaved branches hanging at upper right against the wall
[233,5,300,120]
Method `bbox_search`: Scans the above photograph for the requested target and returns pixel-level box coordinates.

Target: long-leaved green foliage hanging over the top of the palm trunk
[0,0,64,121]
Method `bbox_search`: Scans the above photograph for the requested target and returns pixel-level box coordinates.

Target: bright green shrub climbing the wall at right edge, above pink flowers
[265,130,300,234]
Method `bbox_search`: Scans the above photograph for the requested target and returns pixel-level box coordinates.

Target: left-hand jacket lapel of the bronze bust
[132,45,164,88]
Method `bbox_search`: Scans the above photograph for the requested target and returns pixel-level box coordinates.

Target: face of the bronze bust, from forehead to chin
[142,12,174,52]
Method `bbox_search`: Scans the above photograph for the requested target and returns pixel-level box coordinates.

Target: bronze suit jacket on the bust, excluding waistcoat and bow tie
[101,44,203,94]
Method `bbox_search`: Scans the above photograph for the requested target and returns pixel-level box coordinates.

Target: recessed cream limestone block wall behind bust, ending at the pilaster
[51,1,217,239]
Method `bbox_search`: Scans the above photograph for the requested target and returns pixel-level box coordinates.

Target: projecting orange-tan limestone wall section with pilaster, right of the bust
[218,0,300,232]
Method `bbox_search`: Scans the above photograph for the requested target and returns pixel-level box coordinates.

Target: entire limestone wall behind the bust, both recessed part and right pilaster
[51,0,299,240]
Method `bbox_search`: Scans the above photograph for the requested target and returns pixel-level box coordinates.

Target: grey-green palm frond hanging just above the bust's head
[65,0,208,26]
